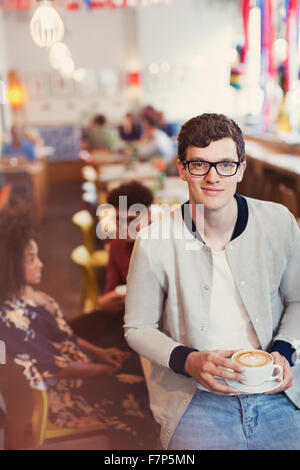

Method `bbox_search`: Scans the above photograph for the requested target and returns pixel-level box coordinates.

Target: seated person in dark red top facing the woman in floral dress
[71,181,153,349]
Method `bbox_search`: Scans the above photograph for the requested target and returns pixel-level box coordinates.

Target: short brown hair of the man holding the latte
[178,113,246,162]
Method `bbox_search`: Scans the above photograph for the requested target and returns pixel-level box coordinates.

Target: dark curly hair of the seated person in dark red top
[107,181,153,209]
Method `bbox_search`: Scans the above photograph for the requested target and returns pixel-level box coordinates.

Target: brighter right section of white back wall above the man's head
[138,0,242,119]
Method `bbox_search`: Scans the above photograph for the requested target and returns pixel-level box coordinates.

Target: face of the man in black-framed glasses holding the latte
[177,138,246,210]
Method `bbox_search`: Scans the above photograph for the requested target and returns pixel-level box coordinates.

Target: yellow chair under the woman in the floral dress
[0,358,107,450]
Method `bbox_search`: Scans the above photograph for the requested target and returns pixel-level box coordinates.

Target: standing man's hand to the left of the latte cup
[185,350,245,395]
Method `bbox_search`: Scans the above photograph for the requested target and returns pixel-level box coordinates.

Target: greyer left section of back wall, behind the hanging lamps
[5,9,136,124]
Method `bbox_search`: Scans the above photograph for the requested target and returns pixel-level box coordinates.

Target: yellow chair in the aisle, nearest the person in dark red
[71,245,108,313]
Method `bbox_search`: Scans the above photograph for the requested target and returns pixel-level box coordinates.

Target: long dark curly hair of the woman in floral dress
[0,201,35,307]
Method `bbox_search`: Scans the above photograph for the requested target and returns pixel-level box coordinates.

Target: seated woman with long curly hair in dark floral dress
[0,203,156,449]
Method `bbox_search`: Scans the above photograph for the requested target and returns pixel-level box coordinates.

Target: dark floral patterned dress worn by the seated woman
[0,294,156,449]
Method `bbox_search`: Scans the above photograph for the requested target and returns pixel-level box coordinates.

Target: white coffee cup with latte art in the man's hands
[231,349,283,386]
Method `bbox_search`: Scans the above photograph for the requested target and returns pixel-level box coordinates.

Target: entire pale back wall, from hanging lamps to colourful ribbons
[0,0,241,124]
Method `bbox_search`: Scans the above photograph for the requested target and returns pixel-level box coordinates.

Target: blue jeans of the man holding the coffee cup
[169,390,300,450]
